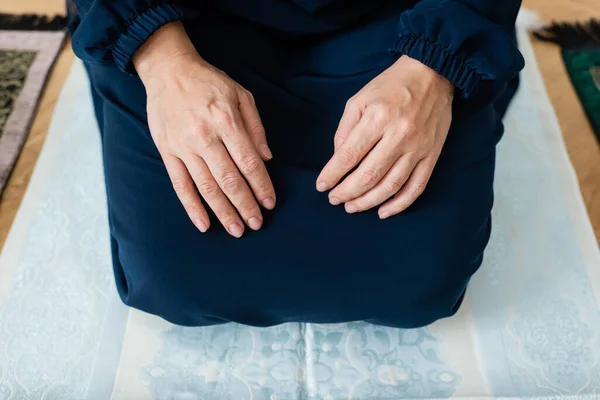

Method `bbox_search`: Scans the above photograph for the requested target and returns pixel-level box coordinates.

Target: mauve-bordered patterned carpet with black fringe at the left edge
[0,14,65,195]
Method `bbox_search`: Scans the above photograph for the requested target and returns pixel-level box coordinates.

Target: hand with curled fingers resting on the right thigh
[317,56,454,219]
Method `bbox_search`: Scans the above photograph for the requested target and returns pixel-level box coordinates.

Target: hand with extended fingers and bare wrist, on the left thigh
[133,22,275,238]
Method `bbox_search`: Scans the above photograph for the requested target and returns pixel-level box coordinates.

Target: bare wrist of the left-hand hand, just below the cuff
[132,21,201,82]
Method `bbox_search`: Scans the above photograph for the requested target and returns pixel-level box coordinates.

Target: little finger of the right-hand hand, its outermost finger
[379,156,437,219]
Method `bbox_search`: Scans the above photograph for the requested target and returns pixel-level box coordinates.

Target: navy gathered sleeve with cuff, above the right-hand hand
[392,0,524,102]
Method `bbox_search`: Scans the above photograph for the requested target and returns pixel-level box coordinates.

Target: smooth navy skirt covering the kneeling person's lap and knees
[75,0,516,328]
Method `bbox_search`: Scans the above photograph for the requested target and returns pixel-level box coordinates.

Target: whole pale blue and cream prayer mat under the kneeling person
[0,24,600,400]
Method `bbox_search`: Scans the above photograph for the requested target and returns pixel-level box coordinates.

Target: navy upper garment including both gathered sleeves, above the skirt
[70,0,523,103]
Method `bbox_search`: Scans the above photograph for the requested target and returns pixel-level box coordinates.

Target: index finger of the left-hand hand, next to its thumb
[223,111,275,210]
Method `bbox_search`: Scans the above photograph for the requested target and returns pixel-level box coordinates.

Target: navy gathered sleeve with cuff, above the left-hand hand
[69,0,196,73]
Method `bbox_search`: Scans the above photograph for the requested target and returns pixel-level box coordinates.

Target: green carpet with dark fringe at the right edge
[534,20,600,141]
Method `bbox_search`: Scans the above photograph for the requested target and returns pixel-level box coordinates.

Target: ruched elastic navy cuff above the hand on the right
[391,34,481,98]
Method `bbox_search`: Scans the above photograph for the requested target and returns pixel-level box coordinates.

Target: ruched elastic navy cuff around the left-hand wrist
[111,3,183,73]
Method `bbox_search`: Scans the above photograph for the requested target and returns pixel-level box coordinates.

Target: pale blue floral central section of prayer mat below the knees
[145,323,462,399]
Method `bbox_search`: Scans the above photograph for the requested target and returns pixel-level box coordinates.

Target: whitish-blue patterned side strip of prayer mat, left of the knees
[0,61,115,399]
